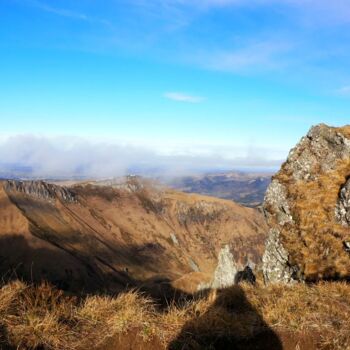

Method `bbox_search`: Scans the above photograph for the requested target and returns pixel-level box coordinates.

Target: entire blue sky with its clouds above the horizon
[0,0,350,177]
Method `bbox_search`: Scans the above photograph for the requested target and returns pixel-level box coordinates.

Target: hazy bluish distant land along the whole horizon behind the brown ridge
[0,163,273,208]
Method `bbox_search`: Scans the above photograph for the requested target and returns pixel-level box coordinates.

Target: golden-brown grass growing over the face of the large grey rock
[275,155,350,281]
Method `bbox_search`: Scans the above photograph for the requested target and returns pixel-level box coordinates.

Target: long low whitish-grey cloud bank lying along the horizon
[0,135,281,178]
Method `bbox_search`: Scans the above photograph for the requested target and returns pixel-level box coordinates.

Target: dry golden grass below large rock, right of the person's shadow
[245,282,350,349]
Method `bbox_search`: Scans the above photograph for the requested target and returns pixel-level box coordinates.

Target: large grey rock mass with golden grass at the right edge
[263,124,350,283]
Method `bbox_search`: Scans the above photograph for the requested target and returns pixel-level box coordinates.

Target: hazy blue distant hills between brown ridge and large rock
[162,172,272,207]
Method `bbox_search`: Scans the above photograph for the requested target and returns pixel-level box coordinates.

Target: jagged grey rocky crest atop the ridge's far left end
[4,180,76,203]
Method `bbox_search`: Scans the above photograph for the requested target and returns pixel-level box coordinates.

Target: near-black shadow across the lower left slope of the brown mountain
[0,235,191,308]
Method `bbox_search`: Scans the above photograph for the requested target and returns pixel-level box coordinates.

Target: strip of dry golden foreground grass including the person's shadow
[0,281,350,350]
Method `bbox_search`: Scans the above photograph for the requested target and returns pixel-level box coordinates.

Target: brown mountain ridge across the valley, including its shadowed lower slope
[0,177,267,292]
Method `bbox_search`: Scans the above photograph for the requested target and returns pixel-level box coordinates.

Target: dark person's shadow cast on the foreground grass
[168,285,282,350]
